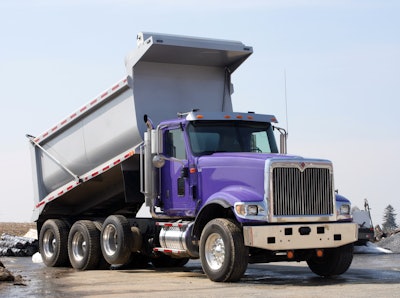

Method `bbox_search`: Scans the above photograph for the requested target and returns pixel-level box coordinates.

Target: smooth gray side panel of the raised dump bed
[31,85,142,204]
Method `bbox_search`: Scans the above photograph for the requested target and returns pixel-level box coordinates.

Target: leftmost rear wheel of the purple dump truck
[39,219,69,267]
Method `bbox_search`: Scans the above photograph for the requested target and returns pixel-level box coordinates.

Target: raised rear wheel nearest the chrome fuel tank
[100,215,133,265]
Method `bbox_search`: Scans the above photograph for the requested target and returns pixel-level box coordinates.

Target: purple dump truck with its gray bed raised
[28,33,358,282]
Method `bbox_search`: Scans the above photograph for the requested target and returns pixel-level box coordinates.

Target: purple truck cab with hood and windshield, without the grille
[155,112,278,217]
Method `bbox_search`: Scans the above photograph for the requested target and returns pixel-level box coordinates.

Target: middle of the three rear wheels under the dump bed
[68,220,101,270]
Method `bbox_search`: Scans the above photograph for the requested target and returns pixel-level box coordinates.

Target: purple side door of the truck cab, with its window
[160,127,196,216]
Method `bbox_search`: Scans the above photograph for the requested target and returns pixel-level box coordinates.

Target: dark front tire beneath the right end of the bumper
[307,243,354,277]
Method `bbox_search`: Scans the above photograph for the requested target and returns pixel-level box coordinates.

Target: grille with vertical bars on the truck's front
[272,167,333,216]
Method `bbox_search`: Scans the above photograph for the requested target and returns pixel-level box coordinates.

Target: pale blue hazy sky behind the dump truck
[0,0,400,223]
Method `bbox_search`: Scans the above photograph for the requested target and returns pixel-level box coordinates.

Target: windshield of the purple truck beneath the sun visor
[188,121,278,156]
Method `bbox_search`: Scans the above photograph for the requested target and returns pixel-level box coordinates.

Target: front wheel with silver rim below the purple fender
[200,218,249,282]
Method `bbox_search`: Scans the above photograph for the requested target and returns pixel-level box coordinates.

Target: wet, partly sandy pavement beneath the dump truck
[0,254,400,297]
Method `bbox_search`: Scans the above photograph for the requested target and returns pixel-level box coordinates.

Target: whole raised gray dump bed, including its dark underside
[30,33,252,221]
